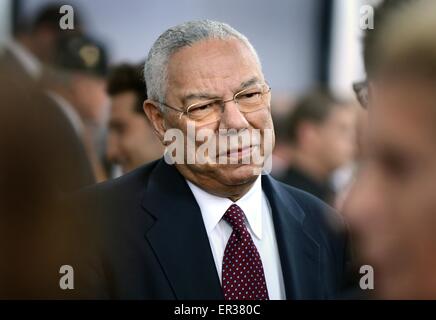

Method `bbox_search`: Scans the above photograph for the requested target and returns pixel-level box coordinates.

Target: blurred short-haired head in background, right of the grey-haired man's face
[287,89,356,174]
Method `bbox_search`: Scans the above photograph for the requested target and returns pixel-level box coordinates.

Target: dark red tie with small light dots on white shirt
[222,204,269,300]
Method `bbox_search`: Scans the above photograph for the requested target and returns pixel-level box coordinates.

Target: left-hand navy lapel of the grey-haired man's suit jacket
[142,160,223,299]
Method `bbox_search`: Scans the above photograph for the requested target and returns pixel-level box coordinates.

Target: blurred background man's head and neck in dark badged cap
[43,34,108,181]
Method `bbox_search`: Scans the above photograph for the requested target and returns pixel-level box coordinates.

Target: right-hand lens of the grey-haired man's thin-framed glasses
[235,85,270,112]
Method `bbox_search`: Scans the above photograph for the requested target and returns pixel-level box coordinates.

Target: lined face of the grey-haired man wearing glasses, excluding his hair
[144,40,273,196]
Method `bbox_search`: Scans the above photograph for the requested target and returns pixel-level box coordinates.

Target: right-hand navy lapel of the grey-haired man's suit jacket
[262,175,322,300]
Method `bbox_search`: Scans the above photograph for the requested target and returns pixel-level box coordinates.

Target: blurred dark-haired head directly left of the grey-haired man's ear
[107,64,163,172]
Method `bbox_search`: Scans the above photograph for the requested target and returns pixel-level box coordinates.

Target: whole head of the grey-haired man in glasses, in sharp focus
[144,20,273,197]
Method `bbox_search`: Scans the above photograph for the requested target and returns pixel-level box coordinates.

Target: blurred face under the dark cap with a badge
[72,73,109,124]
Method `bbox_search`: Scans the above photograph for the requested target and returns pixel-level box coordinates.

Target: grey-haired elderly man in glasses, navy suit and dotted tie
[76,20,346,300]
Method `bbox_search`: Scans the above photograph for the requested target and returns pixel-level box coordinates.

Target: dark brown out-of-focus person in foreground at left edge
[0,69,95,299]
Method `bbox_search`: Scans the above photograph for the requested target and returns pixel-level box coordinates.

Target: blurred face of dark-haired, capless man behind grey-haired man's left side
[107,91,163,172]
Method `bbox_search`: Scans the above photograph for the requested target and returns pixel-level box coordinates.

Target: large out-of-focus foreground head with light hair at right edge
[345,0,436,298]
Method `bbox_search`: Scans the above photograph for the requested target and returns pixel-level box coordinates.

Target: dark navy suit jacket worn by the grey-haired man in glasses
[74,159,346,299]
